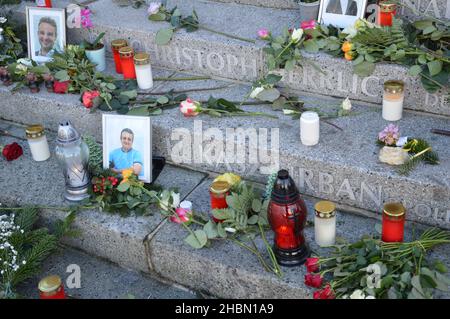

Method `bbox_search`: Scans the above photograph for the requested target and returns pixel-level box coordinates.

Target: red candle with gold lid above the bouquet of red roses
[381,203,405,242]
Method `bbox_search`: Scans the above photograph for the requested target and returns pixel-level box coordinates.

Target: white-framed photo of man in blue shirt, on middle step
[102,114,152,183]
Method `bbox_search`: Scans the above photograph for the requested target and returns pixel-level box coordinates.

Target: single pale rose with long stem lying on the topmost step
[147,2,255,45]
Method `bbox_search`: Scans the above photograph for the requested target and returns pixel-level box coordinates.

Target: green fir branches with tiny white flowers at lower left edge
[0,208,76,299]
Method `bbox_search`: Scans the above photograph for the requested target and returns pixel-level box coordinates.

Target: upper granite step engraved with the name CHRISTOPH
[8,0,450,116]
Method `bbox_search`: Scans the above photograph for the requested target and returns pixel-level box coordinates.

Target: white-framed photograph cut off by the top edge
[318,0,367,28]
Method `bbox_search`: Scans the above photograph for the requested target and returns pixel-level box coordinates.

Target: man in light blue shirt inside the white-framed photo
[109,128,144,177]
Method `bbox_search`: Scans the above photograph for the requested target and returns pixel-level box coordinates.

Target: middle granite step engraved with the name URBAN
[0,65,450,229]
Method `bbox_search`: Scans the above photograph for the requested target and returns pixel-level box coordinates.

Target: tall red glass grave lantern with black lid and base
[268,170,310,266]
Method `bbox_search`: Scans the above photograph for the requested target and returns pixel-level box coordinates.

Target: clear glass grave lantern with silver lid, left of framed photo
[55,121,89,201]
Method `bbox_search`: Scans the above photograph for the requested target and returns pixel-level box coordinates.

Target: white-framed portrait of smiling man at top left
[26,7,66,63]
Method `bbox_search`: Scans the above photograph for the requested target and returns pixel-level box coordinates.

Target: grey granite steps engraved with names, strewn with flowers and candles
[0,0,450,298]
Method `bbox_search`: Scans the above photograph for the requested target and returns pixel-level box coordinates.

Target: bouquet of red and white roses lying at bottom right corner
[305,228,450,299]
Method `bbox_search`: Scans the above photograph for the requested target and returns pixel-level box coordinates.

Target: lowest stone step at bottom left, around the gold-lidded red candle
[17,246,198,299]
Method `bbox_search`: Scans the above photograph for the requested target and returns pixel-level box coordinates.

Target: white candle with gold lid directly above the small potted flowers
[383,80,405,121]
